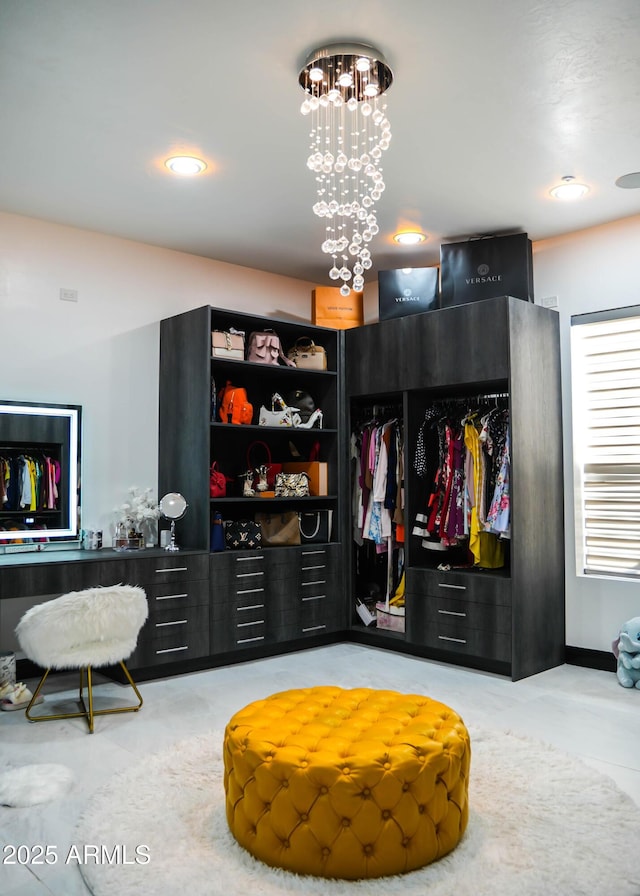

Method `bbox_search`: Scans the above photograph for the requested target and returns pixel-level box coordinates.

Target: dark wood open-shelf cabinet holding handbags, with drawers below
[159,306,348,662]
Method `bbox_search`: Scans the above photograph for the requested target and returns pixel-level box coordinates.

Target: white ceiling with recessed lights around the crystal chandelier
[0,0,640,284]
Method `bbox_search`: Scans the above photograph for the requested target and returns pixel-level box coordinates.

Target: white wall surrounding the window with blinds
[533,215,640,651]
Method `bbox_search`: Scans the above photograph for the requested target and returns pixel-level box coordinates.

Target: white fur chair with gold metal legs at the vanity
[16,585,149,733]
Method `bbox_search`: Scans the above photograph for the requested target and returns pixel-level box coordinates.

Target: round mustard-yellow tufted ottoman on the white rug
[224,687,471,880]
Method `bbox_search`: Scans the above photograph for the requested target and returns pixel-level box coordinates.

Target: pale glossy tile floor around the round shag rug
[0,644,640,896]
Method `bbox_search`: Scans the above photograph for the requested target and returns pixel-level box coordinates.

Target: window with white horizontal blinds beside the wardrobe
[571,306,640,578]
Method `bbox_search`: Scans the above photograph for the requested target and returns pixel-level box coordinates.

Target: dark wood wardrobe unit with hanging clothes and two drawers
[345,296,565,679]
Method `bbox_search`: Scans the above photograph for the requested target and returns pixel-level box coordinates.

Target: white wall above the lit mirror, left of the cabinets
[0,213,313,544]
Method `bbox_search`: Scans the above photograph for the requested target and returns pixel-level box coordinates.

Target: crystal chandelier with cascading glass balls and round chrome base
[298,43,393,296]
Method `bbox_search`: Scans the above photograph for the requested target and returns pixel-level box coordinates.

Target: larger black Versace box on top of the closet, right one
[440,233,533,308]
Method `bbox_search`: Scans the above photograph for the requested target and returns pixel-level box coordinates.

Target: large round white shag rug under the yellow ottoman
[76,729,640,896]
